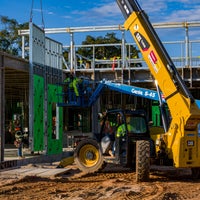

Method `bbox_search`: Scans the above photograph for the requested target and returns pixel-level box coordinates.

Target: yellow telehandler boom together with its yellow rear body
[117,0,200,171]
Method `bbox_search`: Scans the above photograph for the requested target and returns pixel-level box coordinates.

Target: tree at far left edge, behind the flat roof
[0,16,28,56]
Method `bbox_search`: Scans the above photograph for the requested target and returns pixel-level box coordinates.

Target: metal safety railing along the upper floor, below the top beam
[64,40,200,71]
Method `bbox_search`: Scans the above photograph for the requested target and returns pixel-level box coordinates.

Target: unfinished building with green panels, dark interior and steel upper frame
[0,22,200,161]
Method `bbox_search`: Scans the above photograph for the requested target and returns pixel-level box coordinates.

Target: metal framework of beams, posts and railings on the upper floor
[19,21,200,86]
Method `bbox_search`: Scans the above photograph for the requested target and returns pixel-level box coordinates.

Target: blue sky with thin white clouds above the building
[0,0,200,45]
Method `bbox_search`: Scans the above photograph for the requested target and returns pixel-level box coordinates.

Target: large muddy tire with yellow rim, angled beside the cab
[74,139,104,173]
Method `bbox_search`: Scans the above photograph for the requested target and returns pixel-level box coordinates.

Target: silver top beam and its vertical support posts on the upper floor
[19,21,200,72]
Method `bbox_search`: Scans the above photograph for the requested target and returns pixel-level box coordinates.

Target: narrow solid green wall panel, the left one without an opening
[33,75,44,151]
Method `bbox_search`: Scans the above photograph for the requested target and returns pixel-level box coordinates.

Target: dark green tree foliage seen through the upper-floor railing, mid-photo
[63,33,141,67]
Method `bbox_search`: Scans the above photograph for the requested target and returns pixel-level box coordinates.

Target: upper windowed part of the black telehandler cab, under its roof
[100,110,150,140]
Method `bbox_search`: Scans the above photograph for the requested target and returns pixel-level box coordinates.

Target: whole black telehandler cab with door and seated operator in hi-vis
[100,110,150,166]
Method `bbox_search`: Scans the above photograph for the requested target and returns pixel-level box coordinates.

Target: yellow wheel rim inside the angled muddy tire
[79,144,99,167]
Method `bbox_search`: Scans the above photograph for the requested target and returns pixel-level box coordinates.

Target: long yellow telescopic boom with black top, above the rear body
[117,0,198,119]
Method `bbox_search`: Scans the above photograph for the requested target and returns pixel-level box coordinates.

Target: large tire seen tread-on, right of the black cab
[136,140,150,182]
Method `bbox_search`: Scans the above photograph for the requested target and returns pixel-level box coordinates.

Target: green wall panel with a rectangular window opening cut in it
[47,84,63,154]
